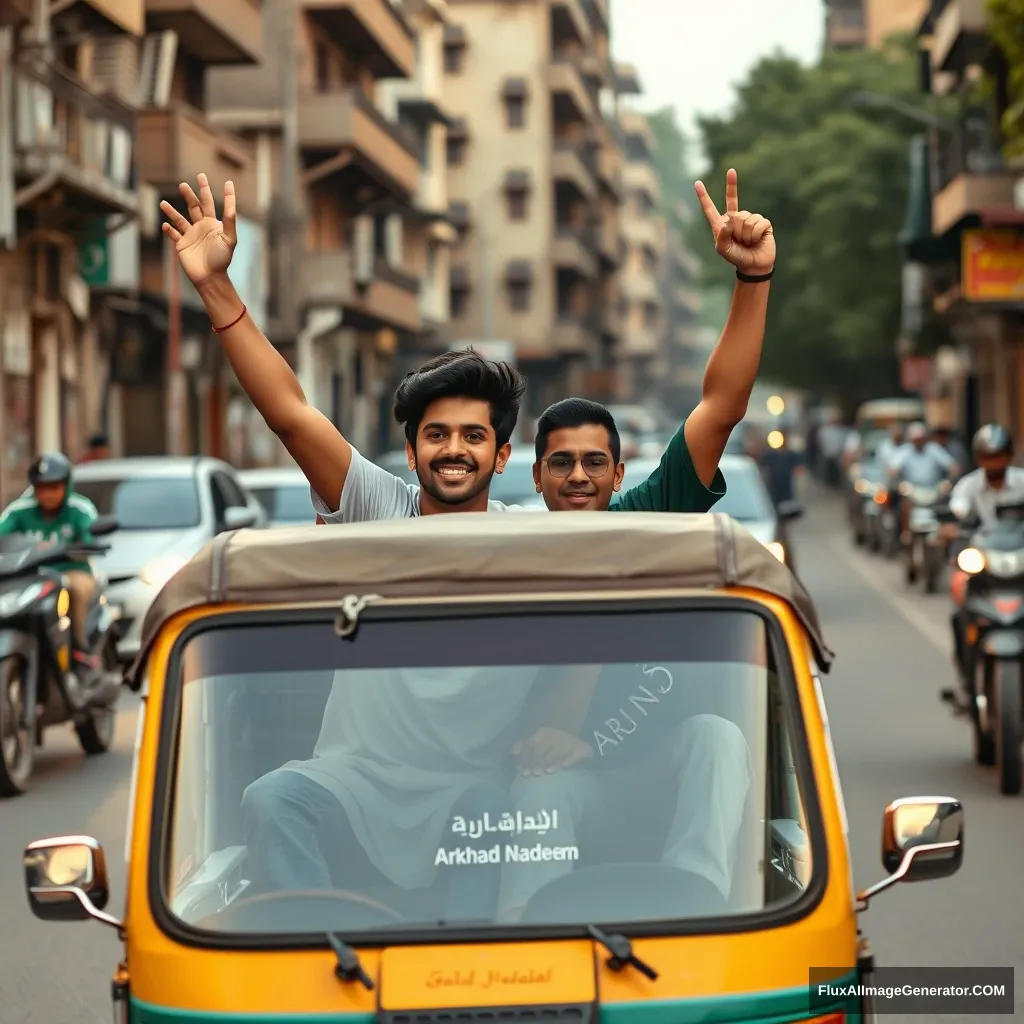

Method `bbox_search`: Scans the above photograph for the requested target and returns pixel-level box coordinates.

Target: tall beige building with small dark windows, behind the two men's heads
[444,0,620,415]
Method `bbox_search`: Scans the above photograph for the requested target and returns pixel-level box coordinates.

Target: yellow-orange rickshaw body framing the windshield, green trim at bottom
[110,513,866,1024]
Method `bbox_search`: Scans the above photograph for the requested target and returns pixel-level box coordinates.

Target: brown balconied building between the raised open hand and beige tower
[209,0,428,458]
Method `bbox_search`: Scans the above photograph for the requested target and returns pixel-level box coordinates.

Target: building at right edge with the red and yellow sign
[906,0,1024,436]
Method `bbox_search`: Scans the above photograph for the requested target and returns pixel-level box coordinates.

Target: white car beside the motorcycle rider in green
[75,456,267,662]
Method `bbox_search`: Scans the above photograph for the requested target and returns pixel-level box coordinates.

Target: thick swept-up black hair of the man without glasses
[394,348,526,447]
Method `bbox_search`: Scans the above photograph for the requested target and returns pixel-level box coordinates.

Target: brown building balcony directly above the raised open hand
[138,106,256,211]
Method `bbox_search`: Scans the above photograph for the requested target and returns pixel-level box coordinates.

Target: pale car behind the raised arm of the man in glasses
[620,455,804,568]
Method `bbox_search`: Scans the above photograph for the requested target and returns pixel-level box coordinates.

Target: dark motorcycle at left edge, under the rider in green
[0,516,122,797]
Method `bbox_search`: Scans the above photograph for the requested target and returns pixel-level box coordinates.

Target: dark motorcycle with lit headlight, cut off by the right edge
[942,504,1024,795]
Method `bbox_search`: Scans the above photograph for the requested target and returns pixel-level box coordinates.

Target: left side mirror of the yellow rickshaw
[23,836,121,928]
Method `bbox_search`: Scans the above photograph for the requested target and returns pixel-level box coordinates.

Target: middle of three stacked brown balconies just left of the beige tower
[299,88,420,201]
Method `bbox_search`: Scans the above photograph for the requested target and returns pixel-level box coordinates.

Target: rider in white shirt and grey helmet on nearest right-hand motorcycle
[941,423,1024,688]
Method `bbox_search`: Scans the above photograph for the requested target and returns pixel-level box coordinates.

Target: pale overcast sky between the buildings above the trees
[611,0,824,170]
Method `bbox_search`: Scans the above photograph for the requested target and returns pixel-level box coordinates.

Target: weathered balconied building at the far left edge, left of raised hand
[0,0,144,502]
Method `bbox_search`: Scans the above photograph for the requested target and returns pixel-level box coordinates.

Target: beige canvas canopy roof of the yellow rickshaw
[130,512,834,681]
